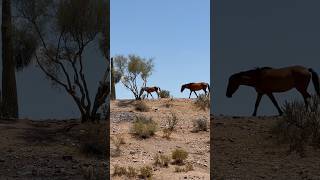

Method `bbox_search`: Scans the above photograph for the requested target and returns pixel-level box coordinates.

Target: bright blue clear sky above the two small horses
[110,0,210,99]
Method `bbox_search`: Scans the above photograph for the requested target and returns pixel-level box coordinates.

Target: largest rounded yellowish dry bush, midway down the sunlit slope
[131,116,158,139]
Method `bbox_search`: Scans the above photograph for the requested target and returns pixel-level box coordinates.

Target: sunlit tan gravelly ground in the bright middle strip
[110,98,210,179]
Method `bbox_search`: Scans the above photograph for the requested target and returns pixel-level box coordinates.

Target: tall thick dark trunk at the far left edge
[1,0,18,118]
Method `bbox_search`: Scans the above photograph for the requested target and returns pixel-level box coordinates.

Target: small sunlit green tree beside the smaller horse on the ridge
[114,55,154,100]
